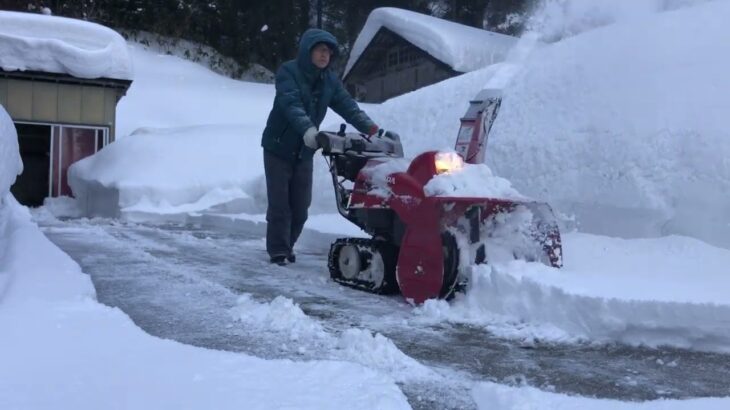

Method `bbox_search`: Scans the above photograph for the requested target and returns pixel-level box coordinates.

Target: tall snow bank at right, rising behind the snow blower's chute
[487,1,730,247]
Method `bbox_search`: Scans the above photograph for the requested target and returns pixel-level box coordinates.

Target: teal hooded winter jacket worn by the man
[261,29,375,162]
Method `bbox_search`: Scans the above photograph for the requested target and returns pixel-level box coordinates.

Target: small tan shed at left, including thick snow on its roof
[0,12,132,206]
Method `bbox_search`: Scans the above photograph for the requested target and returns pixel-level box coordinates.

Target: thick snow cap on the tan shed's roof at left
[0,11,133,80]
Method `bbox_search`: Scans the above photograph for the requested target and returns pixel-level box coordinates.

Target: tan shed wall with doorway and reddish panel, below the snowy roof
[0,70,131,206]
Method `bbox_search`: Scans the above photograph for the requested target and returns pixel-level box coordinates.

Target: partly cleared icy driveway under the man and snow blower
[41,218,730,408]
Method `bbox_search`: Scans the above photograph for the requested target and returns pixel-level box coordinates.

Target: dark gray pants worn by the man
[264,151,313,257]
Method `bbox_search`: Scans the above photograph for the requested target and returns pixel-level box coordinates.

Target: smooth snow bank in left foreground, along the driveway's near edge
[0,196,410,409]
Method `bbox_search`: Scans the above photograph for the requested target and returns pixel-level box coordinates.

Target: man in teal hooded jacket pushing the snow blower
[261,29,378,265]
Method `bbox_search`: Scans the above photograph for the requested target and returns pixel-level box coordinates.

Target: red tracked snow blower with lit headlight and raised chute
[317,90,562,304]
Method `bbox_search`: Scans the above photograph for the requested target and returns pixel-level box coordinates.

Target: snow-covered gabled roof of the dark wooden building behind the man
[345,7,517,75]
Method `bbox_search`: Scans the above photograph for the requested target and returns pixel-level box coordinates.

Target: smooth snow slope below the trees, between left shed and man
[117,43,275,137]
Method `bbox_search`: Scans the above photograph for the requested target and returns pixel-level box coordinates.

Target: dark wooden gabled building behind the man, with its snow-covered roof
[343,7,517,103]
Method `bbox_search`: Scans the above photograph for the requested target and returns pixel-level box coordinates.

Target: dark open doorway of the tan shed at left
[10,124,51,206]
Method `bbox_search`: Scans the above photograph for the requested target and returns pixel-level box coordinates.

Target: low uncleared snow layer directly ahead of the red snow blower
[417,234,730,353]
